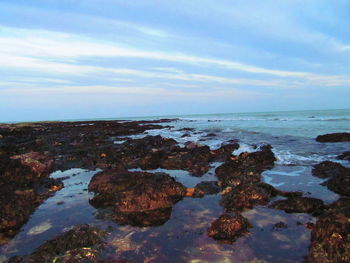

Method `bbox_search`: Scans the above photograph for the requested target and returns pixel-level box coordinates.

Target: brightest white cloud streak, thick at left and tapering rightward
[0,26,320,77]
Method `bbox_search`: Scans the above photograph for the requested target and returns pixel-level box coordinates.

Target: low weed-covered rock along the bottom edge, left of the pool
[8,225,105,263]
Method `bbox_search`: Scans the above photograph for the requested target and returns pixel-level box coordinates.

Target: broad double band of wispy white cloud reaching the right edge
[0,25,350,87]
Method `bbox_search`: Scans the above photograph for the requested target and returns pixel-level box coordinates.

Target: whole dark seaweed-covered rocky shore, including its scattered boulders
[0,122,350,263]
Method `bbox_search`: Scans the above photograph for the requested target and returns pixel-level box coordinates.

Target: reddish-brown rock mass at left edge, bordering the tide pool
[0,153,63,243]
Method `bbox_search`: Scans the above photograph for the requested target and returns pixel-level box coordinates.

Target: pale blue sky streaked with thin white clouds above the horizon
[0,0,350,122]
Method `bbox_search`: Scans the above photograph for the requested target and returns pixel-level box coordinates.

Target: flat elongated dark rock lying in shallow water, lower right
[269,196,324,215]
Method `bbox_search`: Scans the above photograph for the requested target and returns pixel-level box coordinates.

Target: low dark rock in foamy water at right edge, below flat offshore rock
[312,161,350,178]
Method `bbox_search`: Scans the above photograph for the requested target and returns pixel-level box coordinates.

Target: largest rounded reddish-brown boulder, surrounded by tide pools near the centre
[89,170,186,226]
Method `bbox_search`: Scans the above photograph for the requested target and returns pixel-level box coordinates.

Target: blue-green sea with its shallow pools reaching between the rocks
[0,110,350,263]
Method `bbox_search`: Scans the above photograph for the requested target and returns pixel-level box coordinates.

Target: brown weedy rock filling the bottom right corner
[306,198,350,263]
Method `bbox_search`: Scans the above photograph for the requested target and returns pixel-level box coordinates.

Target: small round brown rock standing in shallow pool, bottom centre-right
[208,214,251,242]
